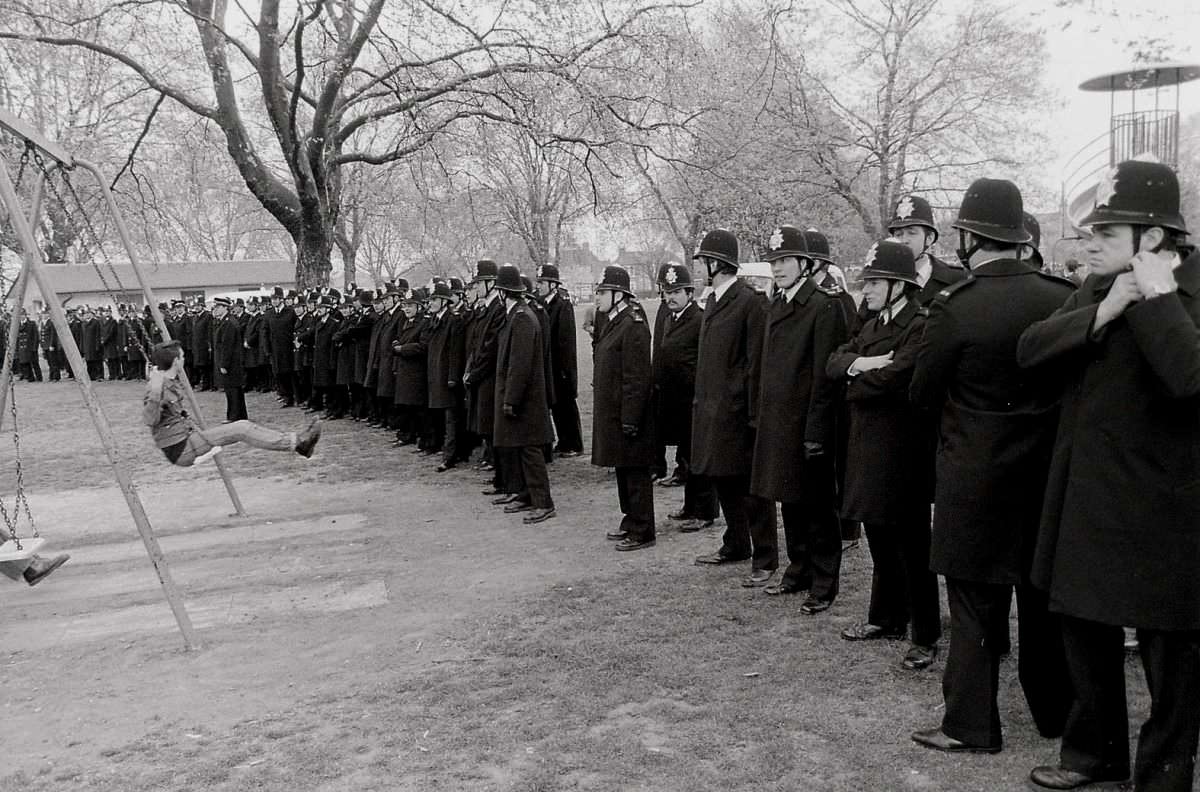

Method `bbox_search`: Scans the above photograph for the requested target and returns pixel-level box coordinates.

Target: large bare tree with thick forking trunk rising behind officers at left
[0,0,686,284]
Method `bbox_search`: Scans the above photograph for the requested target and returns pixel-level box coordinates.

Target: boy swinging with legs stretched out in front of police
[142,341,320,468]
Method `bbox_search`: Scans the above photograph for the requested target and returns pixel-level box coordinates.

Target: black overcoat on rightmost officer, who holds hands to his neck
[1018,253,1200,630]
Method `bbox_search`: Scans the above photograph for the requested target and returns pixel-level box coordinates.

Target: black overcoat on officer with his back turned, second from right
[910,259,1074,584]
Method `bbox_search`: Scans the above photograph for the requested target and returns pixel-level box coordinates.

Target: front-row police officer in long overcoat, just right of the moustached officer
[686,228,779,587]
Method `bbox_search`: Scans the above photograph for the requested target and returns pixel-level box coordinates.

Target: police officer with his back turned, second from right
[910,179,1073,752]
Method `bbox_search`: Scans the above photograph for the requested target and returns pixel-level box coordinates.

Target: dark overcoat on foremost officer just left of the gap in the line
[492,300,554,448]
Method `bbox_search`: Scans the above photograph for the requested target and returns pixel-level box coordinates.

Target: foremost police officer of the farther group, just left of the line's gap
[492,264,556,523]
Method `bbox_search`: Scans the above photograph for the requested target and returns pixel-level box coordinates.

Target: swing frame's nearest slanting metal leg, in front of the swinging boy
[0,148,197,650]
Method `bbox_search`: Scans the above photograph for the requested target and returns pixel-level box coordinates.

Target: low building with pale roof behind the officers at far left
[24,259,296,312]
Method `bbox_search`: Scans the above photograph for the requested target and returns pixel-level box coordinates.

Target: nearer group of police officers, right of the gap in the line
[593,162,1200,792]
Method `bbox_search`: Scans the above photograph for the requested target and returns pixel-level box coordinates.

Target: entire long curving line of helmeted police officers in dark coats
[4,162,1200,792]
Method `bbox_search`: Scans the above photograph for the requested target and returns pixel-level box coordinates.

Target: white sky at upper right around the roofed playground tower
[1013,0,1200,211]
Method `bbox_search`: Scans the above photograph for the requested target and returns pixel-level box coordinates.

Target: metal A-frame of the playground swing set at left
[0,108,246,650]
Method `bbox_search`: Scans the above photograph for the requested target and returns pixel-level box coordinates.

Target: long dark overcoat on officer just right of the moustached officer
[686,281,766,476]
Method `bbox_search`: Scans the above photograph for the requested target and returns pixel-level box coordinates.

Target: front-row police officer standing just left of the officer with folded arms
[750,226,846,616]
